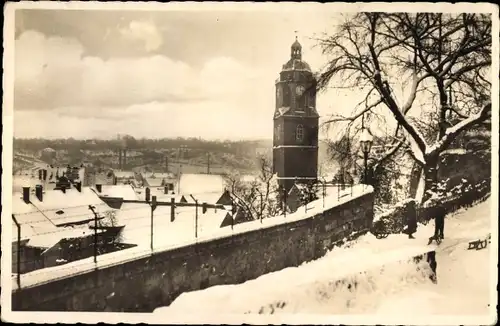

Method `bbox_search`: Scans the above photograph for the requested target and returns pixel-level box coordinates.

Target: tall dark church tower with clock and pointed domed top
[273,39,319,191]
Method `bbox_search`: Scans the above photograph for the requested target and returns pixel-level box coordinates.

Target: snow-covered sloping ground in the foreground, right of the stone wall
[154,199,497,325]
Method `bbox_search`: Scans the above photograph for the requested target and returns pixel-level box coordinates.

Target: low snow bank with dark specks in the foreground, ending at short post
[155,252,430,314]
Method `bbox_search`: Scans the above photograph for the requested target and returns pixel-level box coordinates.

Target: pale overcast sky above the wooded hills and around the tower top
[14,7,376,139]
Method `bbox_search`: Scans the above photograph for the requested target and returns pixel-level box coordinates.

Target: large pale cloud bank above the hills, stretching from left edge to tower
[14,31,275,138]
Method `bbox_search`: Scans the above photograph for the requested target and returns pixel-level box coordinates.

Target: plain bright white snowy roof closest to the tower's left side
[179,174,225,195]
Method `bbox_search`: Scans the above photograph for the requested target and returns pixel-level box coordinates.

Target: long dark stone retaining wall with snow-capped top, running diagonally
[12,193,373,312]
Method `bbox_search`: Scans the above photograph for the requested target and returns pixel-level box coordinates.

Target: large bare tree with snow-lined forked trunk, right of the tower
[318,13,492,205]
